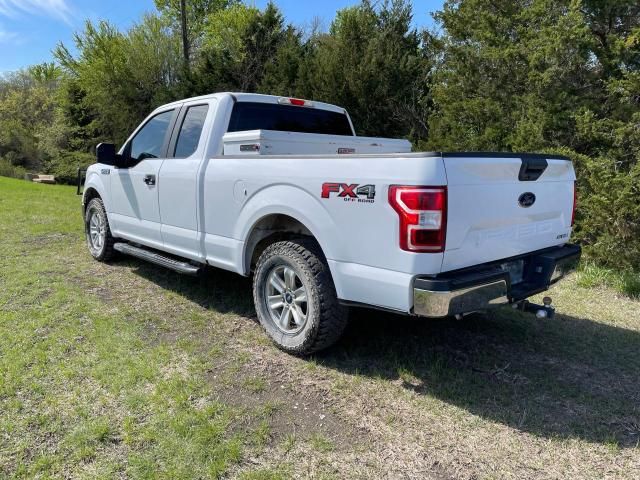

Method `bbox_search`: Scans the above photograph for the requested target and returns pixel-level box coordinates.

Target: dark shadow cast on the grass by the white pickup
[126,260,640,448]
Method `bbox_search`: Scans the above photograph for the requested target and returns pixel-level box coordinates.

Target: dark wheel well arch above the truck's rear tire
[244,213,322,274]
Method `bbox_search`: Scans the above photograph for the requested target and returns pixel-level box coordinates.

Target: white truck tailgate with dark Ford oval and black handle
[442,154,575,272]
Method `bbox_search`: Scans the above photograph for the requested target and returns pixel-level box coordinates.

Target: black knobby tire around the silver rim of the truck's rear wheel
[253,239,348,355]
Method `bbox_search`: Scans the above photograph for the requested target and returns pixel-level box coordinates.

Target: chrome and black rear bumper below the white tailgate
[413,245,581,317]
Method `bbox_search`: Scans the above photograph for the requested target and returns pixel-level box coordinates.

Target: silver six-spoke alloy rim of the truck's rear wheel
[264,265,309,335]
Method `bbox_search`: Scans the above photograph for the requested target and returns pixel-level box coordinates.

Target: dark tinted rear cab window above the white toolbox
[227,102,354,136]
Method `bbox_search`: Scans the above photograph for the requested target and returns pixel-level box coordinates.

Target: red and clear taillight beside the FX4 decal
[389,185,447,253]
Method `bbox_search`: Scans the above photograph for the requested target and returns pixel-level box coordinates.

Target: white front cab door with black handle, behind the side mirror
[111,108,177,247]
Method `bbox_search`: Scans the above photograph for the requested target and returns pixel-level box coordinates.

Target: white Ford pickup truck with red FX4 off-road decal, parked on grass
[82,93,580,354]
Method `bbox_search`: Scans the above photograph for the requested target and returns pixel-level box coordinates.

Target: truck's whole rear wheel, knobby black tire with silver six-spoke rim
[253,239,347,355]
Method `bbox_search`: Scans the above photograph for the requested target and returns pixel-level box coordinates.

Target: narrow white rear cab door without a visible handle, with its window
[158,100,216,261]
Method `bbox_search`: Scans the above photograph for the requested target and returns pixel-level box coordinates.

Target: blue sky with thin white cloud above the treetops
[0,0,443,73]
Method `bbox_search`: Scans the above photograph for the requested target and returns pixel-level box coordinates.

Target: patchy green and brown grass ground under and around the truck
[0,177,640,479]
